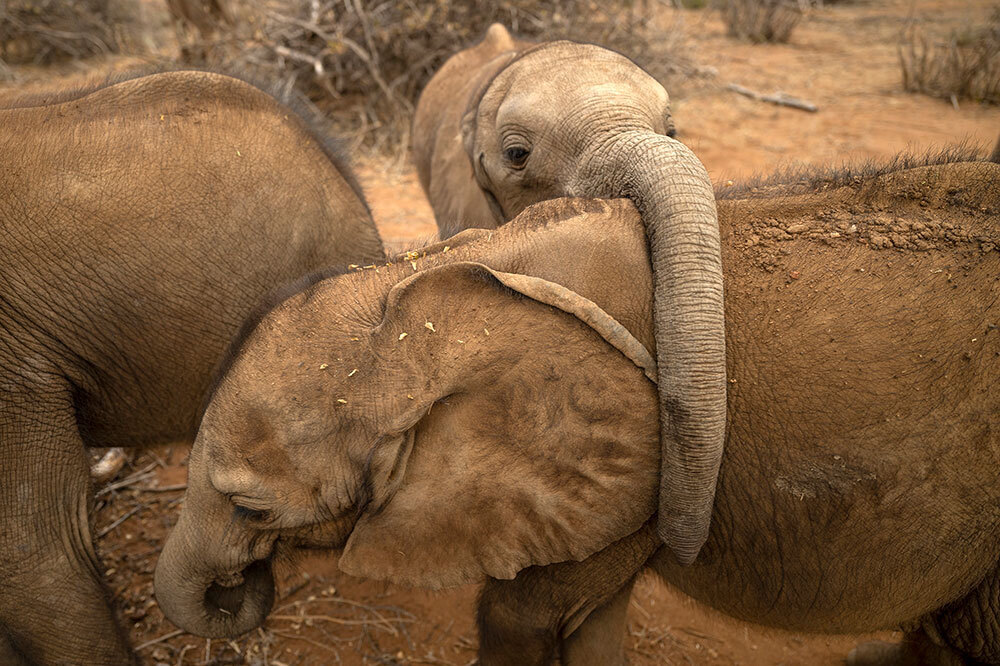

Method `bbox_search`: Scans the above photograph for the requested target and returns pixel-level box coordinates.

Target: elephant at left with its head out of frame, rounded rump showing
[0,72,382,664]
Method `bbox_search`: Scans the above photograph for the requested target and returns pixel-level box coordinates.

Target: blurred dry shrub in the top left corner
[0,0,117,64]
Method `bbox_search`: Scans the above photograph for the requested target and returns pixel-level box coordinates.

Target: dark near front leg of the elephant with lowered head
[477,523,660,666]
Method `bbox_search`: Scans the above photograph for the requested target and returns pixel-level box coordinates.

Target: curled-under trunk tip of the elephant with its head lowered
[153,496,274,638]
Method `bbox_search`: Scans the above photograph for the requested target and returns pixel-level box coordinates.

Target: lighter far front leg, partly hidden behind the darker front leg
[562,578,635,666]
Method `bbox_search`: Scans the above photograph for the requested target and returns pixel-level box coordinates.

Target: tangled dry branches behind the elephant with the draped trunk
[209,0,686,149]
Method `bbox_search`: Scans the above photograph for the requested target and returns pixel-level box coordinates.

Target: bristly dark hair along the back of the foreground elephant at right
[715,141,1000,199]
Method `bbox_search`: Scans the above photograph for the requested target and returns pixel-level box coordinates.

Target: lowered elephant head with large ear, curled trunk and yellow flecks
[155,217,659,636]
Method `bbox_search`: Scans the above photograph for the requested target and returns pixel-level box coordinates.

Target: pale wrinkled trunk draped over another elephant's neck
[577,130,726,564]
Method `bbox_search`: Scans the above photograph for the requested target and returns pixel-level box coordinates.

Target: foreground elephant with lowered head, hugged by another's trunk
[150,154,1000,665]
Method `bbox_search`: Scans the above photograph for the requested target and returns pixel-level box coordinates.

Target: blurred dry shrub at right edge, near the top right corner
[899,7,1000,104]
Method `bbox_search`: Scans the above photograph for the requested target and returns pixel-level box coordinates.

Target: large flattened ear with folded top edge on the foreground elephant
[340,262,659,588]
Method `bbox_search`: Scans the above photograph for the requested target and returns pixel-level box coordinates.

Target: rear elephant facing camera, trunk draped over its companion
[414,25,726,563]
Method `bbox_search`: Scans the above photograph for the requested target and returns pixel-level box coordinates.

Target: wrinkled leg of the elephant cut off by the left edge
[0,371,132,664]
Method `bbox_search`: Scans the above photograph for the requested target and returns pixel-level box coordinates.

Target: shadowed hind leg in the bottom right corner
[848,566,1000,666]
